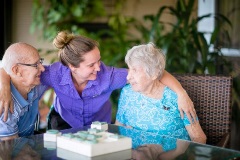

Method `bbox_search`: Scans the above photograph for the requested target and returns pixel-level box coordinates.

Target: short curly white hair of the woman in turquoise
[125,42,166,79]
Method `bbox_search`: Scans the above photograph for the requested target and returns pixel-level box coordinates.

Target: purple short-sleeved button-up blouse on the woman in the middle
[41,62,127,127]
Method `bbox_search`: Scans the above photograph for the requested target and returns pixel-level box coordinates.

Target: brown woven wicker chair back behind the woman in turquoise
[173,74,232,147]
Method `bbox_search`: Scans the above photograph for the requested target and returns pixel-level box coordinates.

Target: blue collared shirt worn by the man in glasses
[0,83,48,137]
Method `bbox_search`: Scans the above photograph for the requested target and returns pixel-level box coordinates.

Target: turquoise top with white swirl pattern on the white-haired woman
[116,85,190,140]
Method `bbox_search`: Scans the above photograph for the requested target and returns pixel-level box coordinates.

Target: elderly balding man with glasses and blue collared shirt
[0,42,48,140]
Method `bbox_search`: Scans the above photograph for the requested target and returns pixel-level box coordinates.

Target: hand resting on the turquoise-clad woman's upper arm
[178,92,197,124]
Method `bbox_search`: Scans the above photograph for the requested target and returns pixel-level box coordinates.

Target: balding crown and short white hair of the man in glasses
[2,42,38,74]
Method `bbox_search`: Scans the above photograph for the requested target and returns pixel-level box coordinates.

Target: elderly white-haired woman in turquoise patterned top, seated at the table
[116,43,206,143]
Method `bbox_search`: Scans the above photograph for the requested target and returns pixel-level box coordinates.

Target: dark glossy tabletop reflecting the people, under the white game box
[0,124,240,160]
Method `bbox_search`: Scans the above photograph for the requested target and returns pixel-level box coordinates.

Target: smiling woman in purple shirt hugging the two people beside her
[0,31,195,129]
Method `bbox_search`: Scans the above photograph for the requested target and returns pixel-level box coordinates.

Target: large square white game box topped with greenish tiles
[57,128,132,157]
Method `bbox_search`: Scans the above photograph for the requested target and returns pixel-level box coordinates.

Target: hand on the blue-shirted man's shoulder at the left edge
[0,87,13,121]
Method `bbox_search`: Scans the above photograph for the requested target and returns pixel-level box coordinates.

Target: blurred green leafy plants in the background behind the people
[31,0,239,121]
